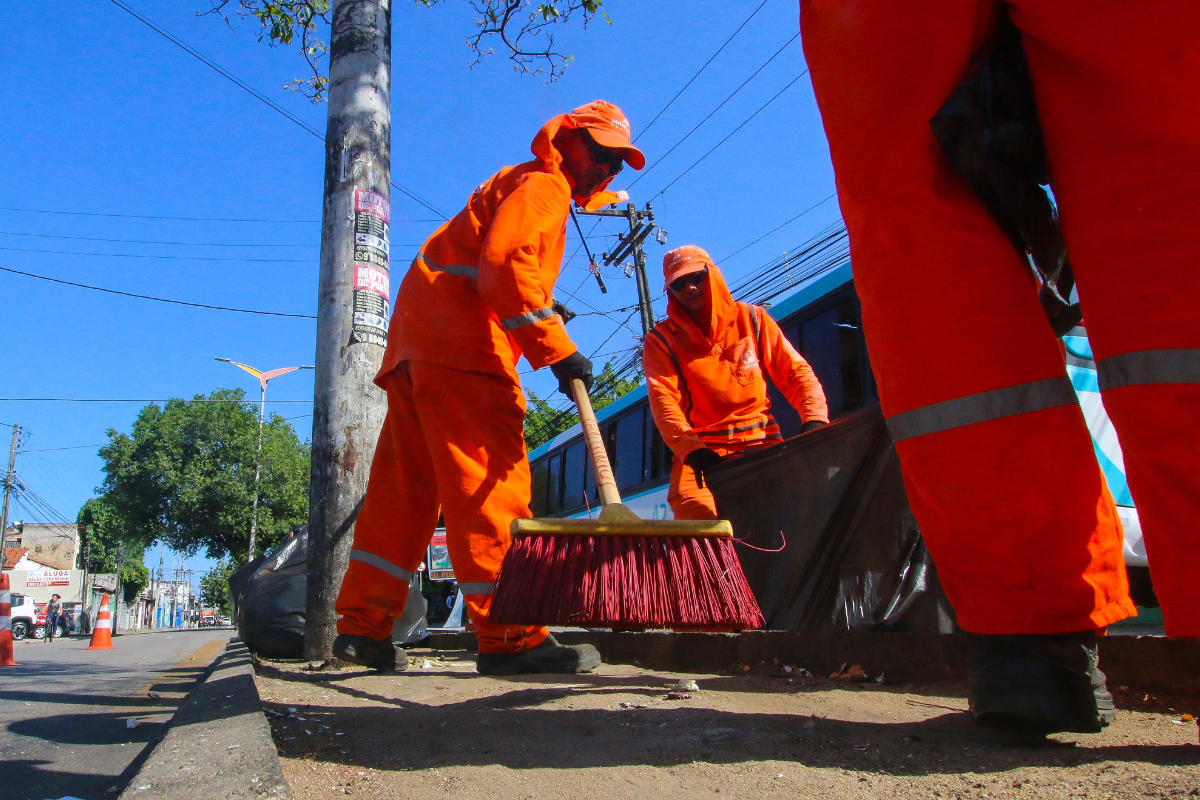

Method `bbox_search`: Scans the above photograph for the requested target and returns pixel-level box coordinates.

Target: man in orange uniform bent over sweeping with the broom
[334,101,646,674]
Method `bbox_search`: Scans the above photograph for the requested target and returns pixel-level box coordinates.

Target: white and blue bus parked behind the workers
[529,260,1146,582]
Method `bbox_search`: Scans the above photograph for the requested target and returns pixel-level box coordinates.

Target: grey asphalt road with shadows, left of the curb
[0,628,233,800]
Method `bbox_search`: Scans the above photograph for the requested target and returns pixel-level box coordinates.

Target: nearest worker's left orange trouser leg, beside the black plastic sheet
[800,0,1134,633]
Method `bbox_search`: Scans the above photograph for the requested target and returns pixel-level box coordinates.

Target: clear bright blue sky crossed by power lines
[0,0,838,578]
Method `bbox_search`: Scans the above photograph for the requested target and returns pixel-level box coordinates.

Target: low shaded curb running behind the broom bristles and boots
[428,630,1200,694]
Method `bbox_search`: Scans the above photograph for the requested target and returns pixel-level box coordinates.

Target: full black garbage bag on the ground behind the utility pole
[229,525,426,658]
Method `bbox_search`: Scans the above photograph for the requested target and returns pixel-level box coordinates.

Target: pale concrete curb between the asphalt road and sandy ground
[121,639,292,800]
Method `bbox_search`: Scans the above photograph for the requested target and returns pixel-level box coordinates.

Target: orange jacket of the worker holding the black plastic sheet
[642,265,829,461]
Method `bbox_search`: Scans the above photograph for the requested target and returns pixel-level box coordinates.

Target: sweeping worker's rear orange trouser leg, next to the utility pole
[336,363,438,639]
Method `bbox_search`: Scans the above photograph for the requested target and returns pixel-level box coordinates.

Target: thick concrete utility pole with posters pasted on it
[305,0,391,661]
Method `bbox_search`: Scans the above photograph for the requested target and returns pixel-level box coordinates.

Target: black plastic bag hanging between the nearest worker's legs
[929,13,1082,336]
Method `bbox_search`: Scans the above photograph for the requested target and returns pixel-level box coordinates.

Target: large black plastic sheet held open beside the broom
[706,405,956,633]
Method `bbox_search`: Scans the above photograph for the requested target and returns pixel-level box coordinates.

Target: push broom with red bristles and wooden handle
[488,380,763,631]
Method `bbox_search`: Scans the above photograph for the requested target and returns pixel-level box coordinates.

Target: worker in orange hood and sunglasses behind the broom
[642,245,829,519]
